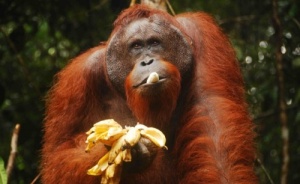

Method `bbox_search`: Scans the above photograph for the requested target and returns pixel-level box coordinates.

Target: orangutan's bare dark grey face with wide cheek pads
[107,17,192,94]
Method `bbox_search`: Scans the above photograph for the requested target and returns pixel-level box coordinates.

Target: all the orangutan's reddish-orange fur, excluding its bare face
[41,6,257,184]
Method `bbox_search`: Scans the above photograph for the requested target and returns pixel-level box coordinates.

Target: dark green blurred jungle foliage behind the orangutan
[0,0,300,184]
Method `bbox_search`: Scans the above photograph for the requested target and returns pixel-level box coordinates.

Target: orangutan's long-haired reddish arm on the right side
[174,13,257,184]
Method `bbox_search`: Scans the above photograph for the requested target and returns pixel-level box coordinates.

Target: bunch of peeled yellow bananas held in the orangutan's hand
[85,119,167,184]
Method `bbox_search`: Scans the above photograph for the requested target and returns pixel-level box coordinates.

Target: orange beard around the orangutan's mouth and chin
[125,62,181,129]
